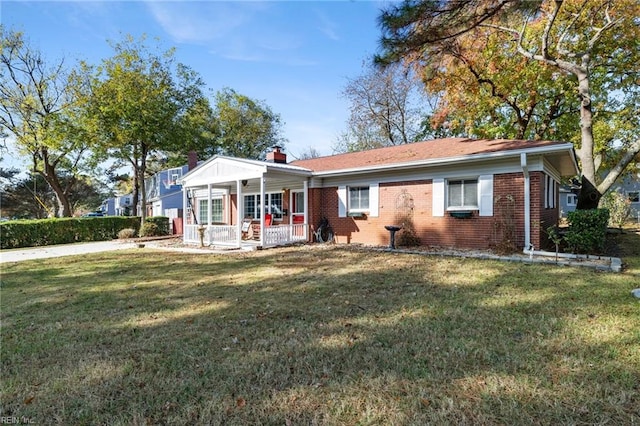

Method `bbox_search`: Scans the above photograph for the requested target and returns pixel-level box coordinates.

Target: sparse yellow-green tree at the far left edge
[0,27,86,216]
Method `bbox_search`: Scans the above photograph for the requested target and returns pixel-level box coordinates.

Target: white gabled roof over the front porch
[179,155,312,187]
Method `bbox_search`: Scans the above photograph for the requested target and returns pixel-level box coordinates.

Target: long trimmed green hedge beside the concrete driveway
[0,216,140,249]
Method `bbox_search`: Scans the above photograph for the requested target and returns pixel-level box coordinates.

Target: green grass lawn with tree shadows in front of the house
[0,233,640,425]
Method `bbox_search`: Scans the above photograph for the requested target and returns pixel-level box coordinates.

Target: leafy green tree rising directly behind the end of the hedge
[76,36,203,220]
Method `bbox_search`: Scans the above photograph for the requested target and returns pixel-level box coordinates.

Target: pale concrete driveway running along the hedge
[0,241,136,263]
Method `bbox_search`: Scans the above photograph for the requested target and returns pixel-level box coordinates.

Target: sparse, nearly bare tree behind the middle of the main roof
[334,63,427,152]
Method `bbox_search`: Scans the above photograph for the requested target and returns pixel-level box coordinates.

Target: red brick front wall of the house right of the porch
[309,173,558,249]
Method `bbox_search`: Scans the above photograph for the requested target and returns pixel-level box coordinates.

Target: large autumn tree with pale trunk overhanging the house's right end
[377,0,640,208]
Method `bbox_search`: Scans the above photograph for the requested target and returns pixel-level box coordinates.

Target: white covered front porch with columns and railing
[182,156,311,248]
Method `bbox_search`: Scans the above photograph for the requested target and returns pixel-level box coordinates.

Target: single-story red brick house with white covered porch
[182,138,578,253]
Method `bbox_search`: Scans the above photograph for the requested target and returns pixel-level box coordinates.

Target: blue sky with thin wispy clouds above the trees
[0,0,396,171]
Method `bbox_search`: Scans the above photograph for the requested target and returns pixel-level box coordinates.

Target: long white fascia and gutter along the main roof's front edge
[313,143,575,177]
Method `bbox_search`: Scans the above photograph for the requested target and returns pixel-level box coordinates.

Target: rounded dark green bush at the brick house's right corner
[564,209,609,253]
